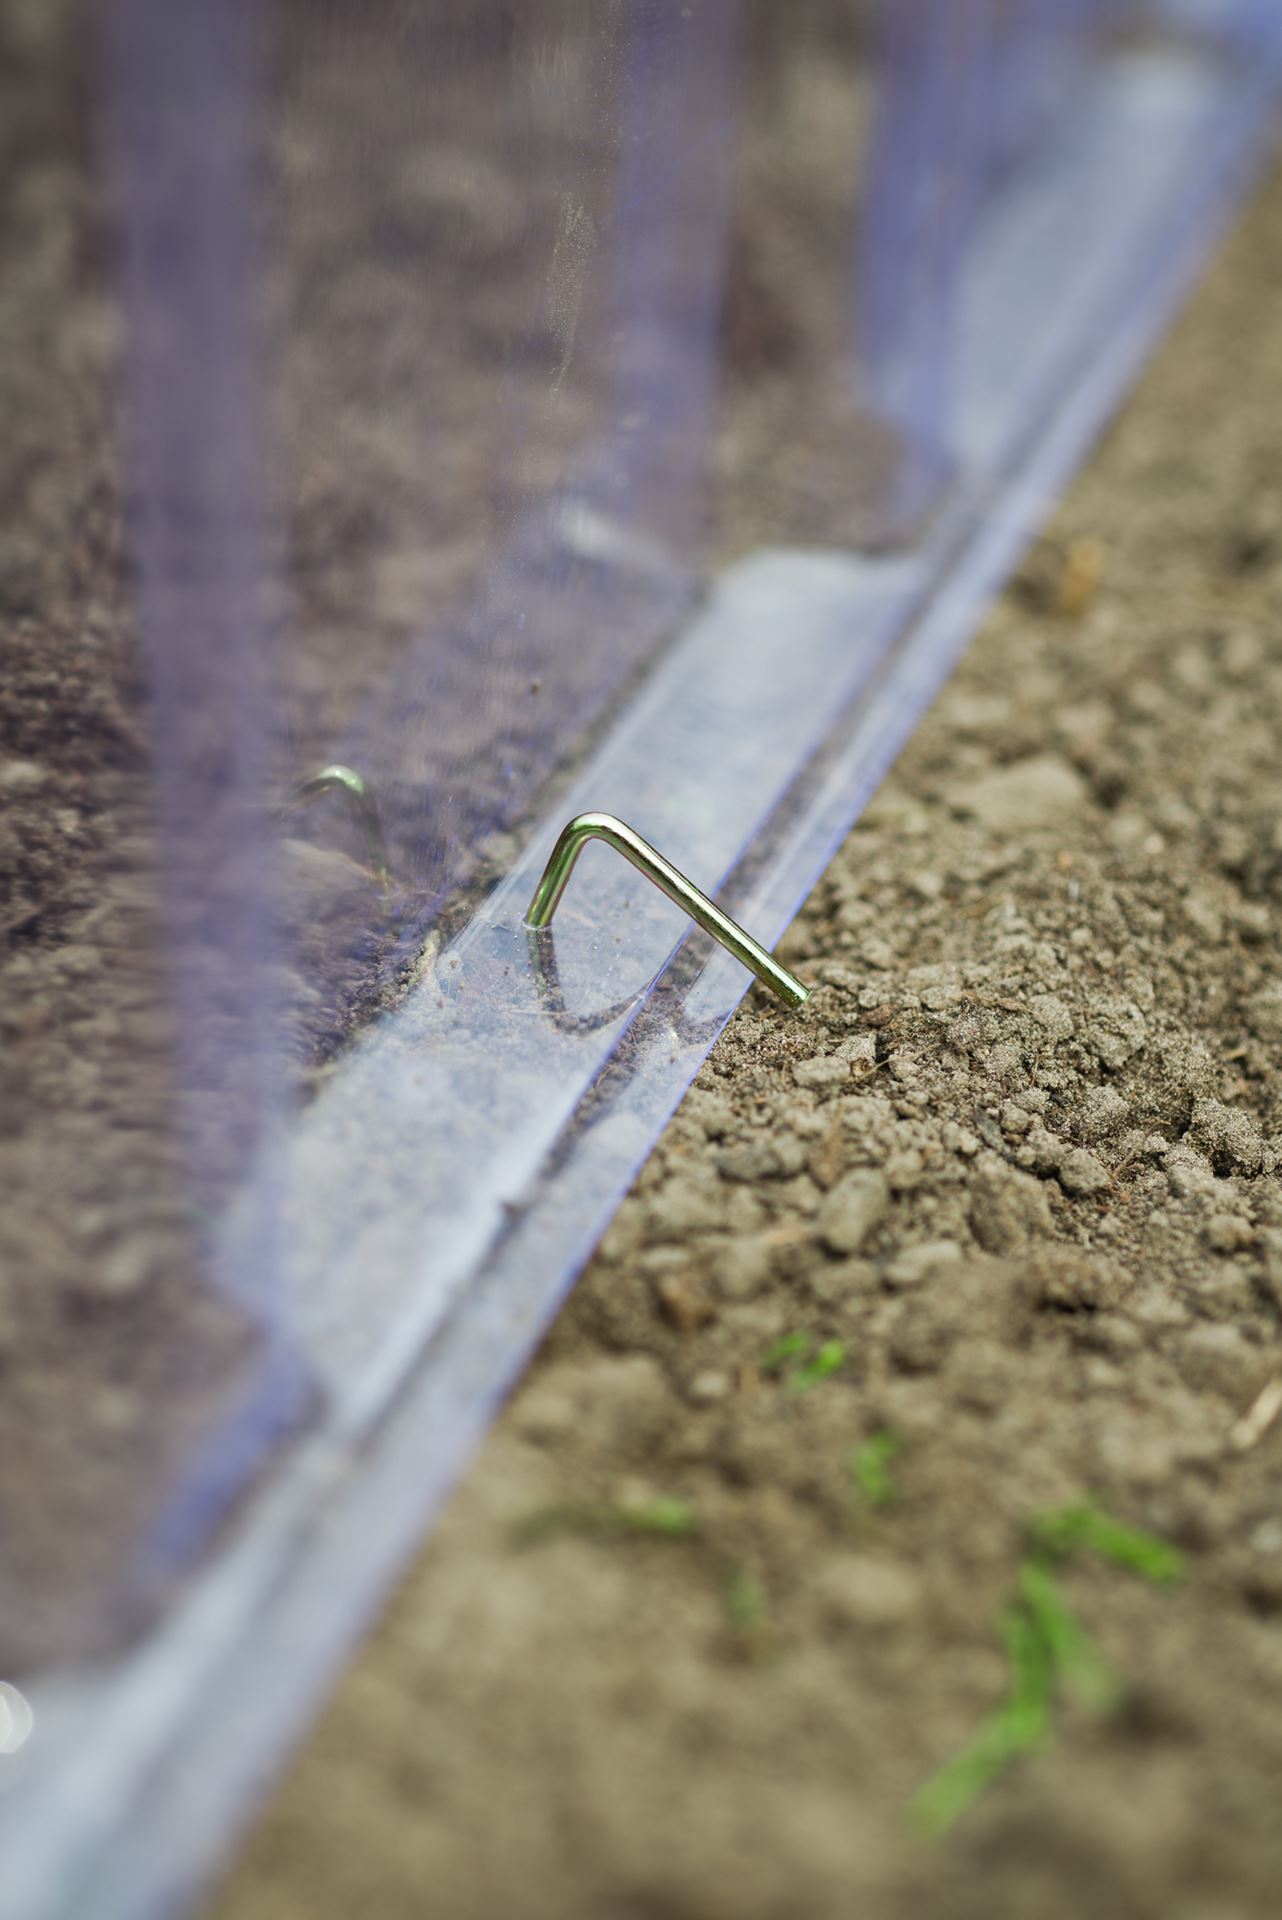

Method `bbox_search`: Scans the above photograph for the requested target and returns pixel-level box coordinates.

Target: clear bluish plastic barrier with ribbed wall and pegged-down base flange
[0,0,1282,1920]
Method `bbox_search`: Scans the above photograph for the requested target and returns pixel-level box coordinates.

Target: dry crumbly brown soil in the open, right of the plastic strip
[213,161,1282,1920]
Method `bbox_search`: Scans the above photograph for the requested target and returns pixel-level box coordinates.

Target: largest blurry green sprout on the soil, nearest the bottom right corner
[912,1501,1184,1837]
